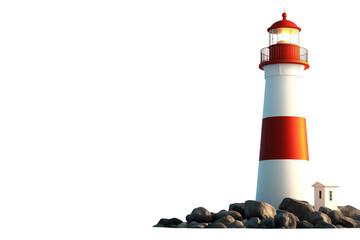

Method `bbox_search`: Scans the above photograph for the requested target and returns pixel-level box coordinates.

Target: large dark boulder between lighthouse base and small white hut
[279,198,314,220]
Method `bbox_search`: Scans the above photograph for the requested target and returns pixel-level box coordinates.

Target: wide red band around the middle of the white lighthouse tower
[260,117,309,161]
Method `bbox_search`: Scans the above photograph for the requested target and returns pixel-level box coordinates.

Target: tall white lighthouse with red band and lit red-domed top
[256,13,309,208]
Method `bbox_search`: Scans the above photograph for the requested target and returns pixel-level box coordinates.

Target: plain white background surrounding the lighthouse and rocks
[0,0,360,239]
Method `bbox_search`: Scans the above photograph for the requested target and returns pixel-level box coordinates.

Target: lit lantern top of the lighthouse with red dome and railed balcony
[259,13,309,70]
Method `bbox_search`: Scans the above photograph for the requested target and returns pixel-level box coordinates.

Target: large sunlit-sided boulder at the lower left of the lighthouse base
[244,200,276,219]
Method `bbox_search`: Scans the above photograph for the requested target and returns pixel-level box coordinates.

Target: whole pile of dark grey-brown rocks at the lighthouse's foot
[154,198,360,228]
